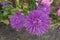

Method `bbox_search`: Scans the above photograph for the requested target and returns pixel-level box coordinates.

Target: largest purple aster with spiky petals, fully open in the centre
[25,10,50,35]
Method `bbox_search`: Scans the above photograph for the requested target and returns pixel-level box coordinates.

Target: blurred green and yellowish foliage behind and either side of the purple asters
[0,0,60,30]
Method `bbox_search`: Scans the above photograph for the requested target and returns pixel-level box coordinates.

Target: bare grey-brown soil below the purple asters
[0,23,60,40]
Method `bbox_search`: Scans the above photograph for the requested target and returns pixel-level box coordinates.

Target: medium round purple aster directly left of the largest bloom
[10,13,25,30]
